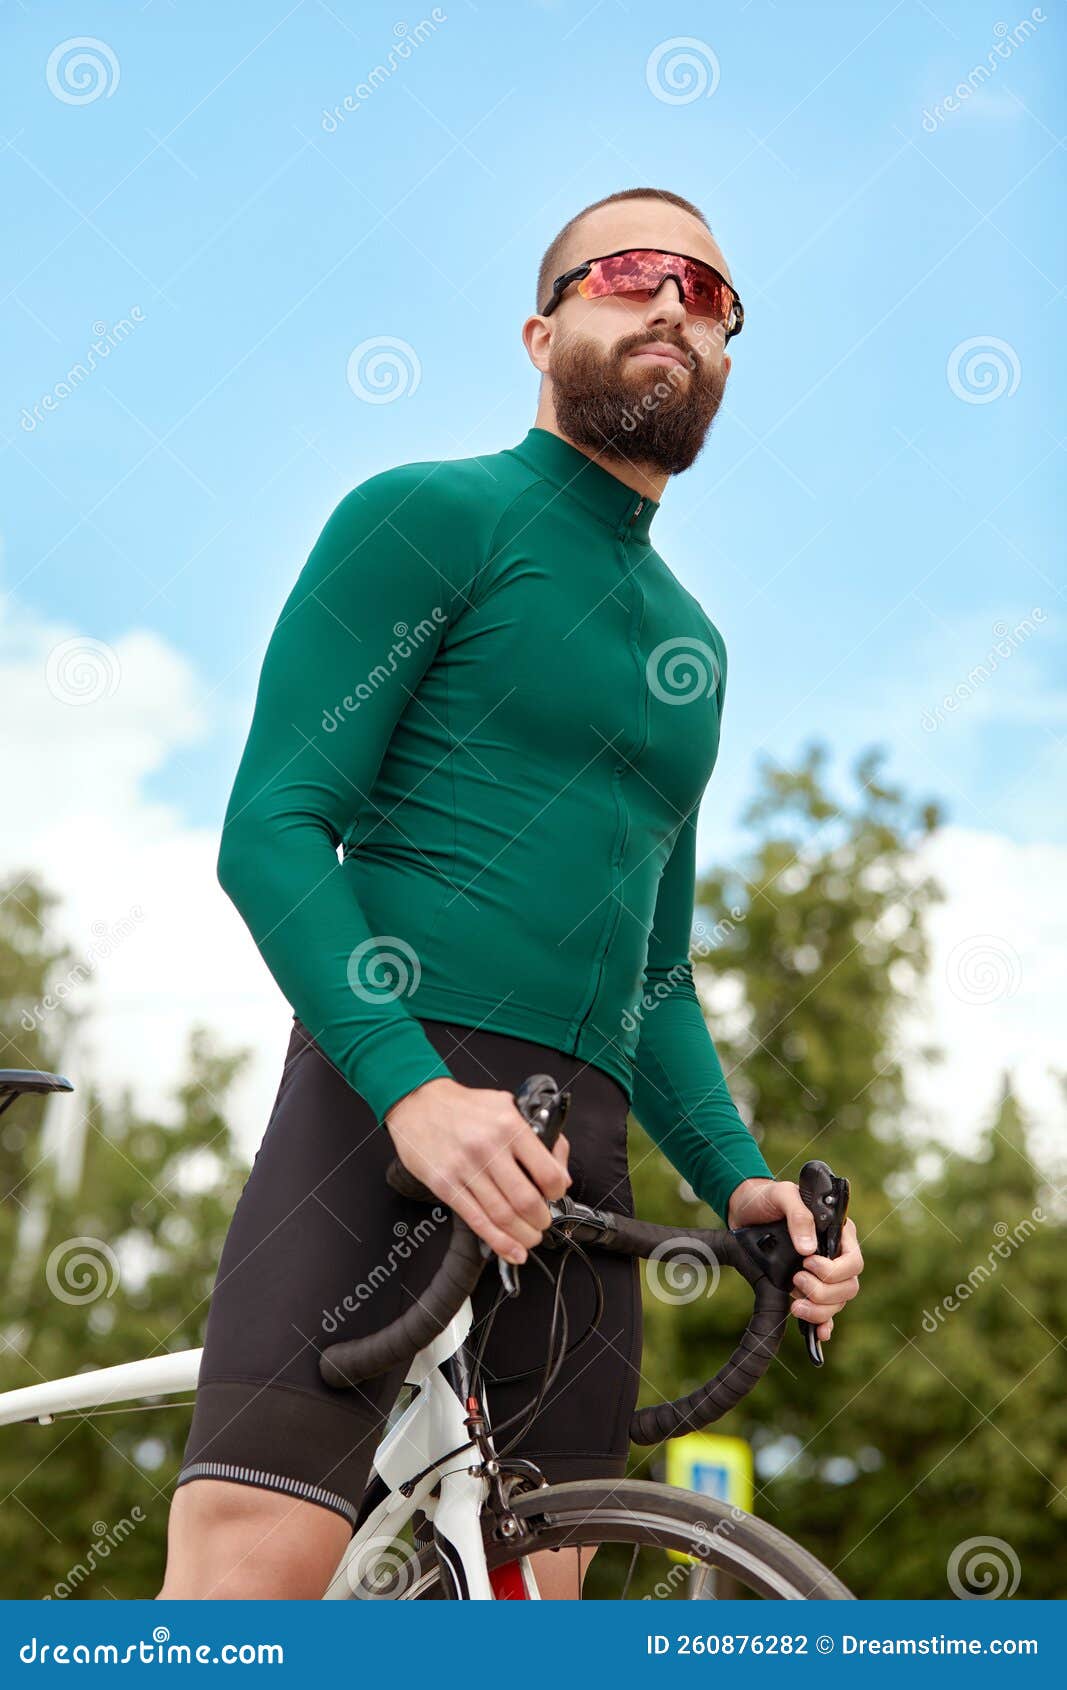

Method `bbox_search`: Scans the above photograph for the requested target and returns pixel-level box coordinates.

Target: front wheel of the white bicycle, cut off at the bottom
[392,1479,852,1600]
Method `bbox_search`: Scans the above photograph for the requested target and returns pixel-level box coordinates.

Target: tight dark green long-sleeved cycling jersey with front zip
[218,428,768,1213]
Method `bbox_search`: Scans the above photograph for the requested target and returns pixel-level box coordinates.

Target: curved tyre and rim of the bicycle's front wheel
[355,1479,856,1602]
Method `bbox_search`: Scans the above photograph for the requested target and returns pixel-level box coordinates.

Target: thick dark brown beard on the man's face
[548,324,725,475]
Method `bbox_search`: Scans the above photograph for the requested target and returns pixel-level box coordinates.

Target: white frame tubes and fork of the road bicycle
[0,1301,538,1602]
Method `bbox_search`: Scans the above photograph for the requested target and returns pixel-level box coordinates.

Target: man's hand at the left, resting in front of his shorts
[386,1080,570,1262]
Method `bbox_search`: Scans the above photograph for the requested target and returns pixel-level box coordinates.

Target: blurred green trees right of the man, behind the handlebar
[631,750,1064,1597]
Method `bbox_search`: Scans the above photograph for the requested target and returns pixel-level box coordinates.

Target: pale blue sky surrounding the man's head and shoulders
[0,0,1067,1149]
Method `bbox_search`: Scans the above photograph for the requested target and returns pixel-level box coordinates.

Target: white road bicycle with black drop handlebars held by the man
[0,1070,852,1600]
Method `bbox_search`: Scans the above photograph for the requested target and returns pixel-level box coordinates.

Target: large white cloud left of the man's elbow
[0,594,289,1151]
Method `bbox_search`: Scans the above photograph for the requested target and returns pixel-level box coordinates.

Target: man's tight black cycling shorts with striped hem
[178,1021,641,1526]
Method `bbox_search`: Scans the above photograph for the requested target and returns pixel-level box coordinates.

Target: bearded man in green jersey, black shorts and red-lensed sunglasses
[162,189,862,1599]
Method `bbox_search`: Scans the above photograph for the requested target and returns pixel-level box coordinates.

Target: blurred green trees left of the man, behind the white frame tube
[0,886,245,1599]
